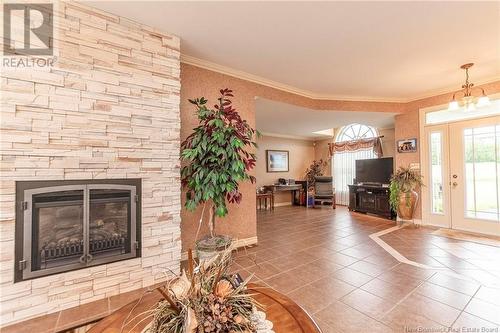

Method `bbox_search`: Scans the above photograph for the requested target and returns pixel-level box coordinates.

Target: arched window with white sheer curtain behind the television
[332,124,378,205]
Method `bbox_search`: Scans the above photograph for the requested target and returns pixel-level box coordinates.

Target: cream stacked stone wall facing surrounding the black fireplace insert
[0,2,181,326]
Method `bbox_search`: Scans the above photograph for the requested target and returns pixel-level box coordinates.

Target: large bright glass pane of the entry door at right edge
[464,126,500,221]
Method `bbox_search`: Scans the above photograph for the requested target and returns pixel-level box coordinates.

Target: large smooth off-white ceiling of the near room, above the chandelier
[87,1,500,101]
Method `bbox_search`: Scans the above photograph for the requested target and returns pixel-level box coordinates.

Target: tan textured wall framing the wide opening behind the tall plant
[181,64,500,244]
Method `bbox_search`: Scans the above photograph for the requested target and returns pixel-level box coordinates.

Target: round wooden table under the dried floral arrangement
[87,284,321,333]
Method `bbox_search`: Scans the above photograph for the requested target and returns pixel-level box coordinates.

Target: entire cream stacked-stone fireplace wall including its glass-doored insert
[0,1,181,326]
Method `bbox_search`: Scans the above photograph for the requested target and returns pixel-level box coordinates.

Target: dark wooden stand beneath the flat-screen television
[349,184,396,219]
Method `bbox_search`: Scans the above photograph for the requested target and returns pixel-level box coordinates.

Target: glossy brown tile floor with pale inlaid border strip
[235,207,500,333]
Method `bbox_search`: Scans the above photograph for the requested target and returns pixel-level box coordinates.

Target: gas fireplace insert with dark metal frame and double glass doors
[16,180,140,280]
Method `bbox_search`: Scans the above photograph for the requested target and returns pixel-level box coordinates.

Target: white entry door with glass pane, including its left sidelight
[422,116,500,235]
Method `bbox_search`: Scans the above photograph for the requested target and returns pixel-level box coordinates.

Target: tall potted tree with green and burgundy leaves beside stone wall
[181,89,257,260]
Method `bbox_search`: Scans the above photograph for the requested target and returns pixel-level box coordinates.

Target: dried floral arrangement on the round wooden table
[148,249,257,333]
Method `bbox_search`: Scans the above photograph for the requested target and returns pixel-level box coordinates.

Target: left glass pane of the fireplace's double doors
[31,190,83,271]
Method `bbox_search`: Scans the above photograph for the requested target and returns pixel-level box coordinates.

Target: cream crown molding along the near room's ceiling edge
[181,54,500,103]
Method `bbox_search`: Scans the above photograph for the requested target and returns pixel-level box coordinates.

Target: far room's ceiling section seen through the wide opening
[255,97,396,139]
